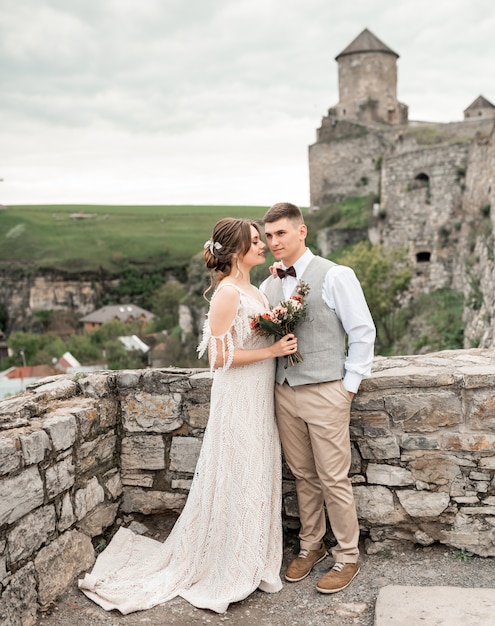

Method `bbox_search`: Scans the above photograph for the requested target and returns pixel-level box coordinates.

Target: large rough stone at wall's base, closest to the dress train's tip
[34,530,95,610]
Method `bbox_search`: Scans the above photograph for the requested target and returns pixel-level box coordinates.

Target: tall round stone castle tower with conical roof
[329,28,408,124]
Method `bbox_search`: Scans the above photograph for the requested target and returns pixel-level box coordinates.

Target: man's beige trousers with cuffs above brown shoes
[275,380,359,563]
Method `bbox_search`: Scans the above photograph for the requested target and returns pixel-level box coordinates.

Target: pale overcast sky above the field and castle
[0,0,495,206]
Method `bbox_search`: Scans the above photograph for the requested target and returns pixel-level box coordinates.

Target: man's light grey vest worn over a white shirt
[264,256,345,387]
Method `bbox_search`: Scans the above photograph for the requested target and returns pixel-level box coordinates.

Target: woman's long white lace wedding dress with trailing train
[79,290,282,614]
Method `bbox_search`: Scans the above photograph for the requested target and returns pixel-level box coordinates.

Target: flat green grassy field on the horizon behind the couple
[0,205,267,273]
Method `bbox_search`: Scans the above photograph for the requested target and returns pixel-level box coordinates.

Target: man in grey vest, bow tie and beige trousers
[261,202,375,593]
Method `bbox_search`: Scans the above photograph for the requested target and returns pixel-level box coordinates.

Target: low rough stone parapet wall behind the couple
[0,350,495,626]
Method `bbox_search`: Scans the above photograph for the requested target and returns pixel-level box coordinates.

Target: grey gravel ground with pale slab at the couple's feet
[37,542,495,626]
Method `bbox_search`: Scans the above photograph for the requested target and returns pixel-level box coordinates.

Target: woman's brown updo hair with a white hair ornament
[203,217,261,297]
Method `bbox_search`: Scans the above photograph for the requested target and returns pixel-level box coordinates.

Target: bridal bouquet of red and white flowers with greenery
[250,280,309,365]
